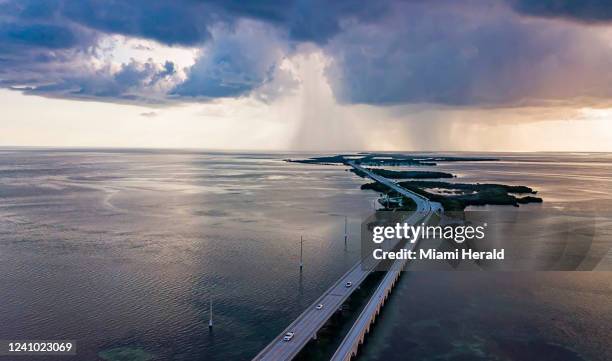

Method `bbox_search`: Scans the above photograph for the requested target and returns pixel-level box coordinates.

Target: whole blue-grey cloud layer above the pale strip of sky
[0,0,612,107]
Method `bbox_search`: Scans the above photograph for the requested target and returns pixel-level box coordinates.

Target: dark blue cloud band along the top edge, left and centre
[1,0,388,46]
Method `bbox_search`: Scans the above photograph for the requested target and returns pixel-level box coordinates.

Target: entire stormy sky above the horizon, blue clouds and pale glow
[0,0,612,151]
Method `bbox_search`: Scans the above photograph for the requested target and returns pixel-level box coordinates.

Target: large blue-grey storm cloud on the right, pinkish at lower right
[326,1,612,106]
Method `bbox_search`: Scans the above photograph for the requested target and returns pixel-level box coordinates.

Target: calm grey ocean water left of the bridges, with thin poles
[0,149,375,360]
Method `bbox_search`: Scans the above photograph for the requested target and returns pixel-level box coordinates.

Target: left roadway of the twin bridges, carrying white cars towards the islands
[253,162,436,361]
